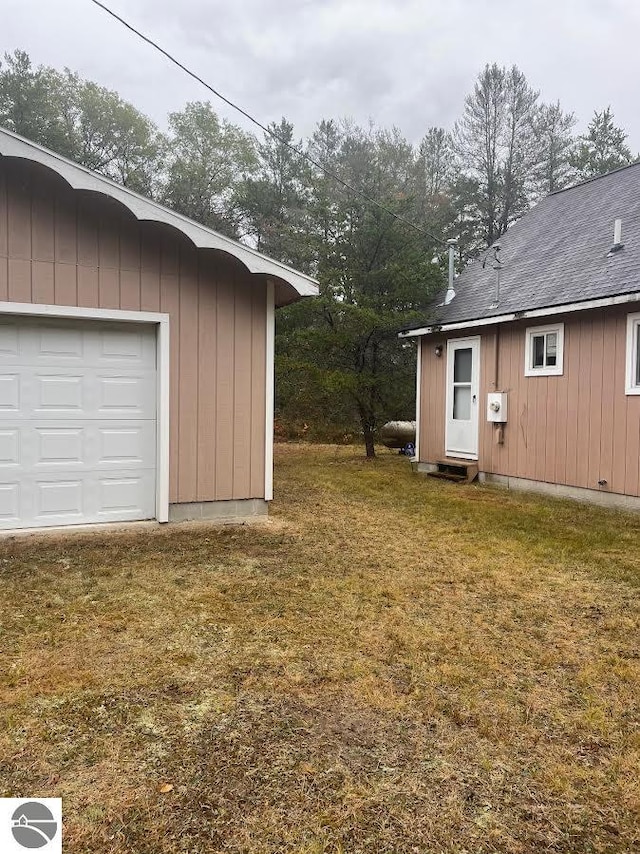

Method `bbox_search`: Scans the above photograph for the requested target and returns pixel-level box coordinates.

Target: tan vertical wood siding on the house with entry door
[419,306,640,496]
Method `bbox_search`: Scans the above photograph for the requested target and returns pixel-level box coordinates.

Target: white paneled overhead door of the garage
[0,316,156,529]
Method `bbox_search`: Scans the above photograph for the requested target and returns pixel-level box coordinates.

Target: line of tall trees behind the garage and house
[0,51,636,456]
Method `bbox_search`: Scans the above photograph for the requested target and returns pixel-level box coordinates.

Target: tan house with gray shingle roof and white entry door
[401,164,640,508]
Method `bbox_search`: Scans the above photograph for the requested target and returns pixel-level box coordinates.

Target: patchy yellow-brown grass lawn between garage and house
[0,446,640,854]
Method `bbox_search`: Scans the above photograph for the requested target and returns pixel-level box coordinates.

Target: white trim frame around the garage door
[0,302,170,524]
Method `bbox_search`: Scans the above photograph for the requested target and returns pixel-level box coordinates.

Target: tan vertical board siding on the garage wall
[0,160,267,503]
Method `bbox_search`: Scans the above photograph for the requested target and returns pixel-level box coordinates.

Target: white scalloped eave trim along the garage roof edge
[0,128,318,298]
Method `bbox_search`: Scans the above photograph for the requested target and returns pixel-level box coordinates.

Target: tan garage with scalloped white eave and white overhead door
[0,130,317,529]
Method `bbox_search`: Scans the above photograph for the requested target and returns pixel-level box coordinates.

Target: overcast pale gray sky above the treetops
[0,0,640,152]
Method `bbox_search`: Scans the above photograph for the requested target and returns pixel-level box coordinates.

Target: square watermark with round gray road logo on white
[0,798,62,854]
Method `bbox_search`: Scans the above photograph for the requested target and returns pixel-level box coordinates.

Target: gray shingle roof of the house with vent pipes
[429,163,640,324]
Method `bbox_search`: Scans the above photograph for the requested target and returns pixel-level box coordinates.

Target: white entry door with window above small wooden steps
[445,338,480,460]
